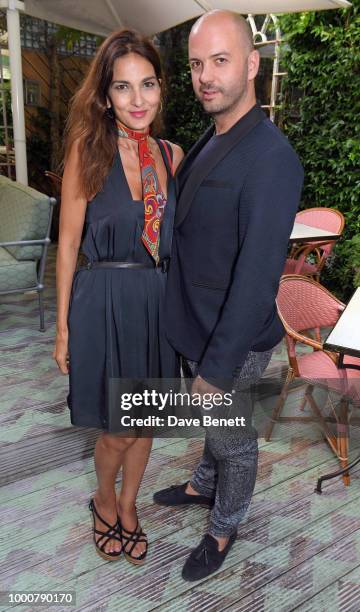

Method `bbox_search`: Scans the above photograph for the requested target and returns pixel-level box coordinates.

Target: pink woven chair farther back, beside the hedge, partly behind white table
[283,207,345,281]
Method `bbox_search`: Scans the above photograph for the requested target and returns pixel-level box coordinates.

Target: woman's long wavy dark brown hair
[64,30,164,200]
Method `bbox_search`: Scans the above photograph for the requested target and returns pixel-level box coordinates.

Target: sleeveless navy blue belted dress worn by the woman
[68,141,179,431]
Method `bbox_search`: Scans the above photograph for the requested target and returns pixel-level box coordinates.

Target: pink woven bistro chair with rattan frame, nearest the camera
[265,275,360,485]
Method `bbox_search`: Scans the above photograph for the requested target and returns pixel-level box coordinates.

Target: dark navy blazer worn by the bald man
[165,105,303,386]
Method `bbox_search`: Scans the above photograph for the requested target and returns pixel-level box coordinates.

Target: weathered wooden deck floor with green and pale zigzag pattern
[0,246,360,612]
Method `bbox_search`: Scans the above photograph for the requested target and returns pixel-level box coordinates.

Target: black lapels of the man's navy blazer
[175,105,266,226]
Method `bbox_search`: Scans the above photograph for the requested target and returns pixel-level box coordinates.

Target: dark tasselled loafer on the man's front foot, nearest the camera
[182,531,236,582]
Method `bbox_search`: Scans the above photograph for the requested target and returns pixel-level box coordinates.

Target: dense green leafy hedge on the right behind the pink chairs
[281,0,360,300]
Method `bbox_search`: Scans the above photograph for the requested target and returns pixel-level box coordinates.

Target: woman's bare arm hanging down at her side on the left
[53,143,87,374]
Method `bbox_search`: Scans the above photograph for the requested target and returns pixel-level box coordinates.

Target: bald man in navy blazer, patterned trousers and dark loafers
[154,10,303,580]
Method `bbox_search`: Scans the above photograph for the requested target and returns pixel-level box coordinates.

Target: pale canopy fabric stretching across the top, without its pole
[25,0,350,35]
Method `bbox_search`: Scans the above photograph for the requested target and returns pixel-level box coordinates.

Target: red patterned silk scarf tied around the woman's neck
[117,121,166,263]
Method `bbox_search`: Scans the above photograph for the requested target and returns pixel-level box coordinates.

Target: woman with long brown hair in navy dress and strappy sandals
[54,30,183,564]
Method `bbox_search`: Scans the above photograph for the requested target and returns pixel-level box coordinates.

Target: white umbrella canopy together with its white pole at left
[0,0,351,184]
